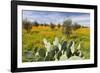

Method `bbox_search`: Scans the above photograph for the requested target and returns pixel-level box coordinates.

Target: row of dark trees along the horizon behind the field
[22,19,87,34]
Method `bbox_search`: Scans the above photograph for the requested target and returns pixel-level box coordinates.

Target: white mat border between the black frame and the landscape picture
[17,5,94,68]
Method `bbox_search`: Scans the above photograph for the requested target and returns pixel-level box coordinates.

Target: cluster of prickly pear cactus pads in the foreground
[24,37,84,62]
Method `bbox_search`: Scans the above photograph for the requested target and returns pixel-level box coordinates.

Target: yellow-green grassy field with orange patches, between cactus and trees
[22,26,90,62]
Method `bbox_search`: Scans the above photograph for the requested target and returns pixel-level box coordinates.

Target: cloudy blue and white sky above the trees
[22,10,90,26]
